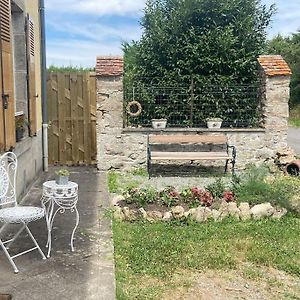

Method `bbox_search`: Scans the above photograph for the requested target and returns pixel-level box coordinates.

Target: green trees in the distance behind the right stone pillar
[266,31,300,107]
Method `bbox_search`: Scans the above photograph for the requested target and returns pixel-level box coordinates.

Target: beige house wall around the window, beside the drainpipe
[12,0,43,199]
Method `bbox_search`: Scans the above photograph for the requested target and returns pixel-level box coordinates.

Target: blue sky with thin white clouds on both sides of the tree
[45,0,300,67]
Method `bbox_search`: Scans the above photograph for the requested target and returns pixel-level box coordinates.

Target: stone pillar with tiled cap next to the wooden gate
[96,56,124,170]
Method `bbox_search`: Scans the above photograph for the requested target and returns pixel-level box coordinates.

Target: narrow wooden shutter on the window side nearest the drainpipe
[26,15,37,136]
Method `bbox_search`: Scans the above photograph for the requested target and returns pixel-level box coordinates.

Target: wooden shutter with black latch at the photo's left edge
[0,0,16,150]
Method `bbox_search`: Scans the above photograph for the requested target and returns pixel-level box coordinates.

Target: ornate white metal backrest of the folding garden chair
[0,152,17,208]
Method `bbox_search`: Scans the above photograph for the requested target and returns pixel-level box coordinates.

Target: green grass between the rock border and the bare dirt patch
[113,215,300,300]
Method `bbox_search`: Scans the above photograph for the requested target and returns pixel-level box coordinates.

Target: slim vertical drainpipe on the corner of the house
[39,0,48,172]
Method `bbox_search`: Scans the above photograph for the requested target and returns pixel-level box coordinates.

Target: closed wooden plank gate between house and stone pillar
[47,72,97,165]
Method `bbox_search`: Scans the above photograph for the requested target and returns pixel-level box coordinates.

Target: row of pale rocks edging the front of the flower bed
[112,195,287,222]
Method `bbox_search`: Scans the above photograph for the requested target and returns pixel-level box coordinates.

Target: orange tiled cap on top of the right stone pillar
[258,55,292,76]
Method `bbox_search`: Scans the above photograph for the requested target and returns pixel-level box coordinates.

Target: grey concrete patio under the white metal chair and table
[0,167,115,300]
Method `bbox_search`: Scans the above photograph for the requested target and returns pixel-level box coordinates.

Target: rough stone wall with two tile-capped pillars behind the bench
[96,56,290,170]
